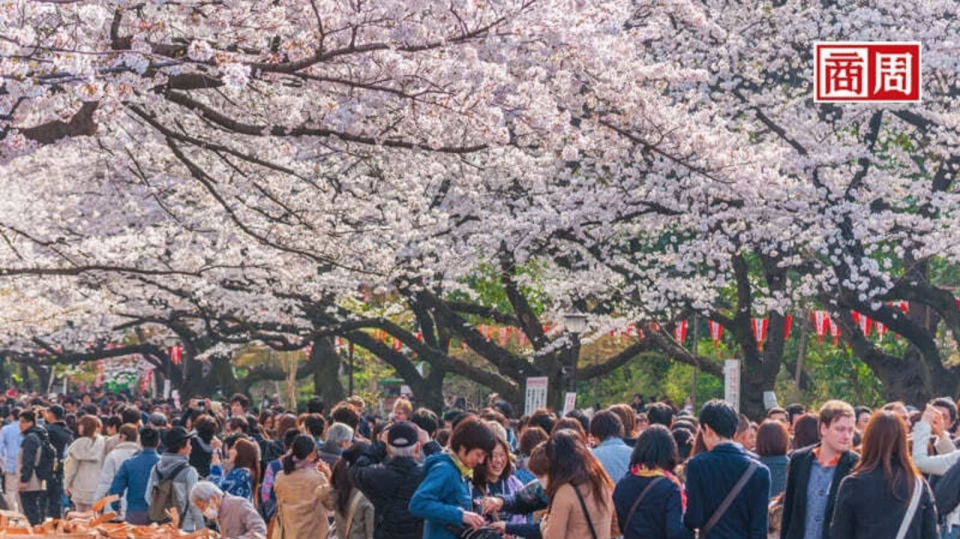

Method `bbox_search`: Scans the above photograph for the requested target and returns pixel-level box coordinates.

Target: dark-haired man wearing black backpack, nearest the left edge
[17,410,57,526]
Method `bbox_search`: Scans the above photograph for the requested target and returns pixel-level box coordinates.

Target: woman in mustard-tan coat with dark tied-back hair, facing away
[272,434,330,539]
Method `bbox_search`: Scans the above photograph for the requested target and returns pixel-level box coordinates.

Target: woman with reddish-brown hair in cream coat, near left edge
[63,415,106,512]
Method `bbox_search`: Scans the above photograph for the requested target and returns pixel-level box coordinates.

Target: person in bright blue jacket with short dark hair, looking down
[409,416,497,539]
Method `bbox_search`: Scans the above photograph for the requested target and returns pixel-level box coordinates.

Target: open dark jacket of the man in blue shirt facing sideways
[780,444,860,539]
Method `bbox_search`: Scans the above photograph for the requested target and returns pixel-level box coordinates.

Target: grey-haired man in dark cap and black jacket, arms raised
[350,421,430,539]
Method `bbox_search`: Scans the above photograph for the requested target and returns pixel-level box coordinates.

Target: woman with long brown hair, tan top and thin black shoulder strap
[540,429,614,539]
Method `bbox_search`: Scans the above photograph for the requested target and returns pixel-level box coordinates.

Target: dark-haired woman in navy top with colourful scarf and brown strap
[613,425,693,539]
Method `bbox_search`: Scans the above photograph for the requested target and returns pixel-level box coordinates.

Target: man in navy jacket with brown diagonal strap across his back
[684,399,770,539]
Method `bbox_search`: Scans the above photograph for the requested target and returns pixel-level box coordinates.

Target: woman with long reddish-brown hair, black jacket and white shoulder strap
[830,410,939,539]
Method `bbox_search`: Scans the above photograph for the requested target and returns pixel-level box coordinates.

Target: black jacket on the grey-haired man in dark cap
[350,442,423,539]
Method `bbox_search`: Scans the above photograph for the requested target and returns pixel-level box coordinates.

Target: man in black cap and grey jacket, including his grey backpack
[146,427,204,532]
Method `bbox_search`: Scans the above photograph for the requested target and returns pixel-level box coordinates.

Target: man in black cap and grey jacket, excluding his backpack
[145,427,204,532]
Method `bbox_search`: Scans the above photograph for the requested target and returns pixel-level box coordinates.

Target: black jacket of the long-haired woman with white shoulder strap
[830,468,940,539]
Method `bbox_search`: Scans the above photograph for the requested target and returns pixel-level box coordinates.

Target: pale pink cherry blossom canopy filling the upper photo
[0,0,960,414]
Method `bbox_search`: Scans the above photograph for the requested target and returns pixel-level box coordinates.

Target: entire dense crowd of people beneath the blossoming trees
[0,388,960,539]
